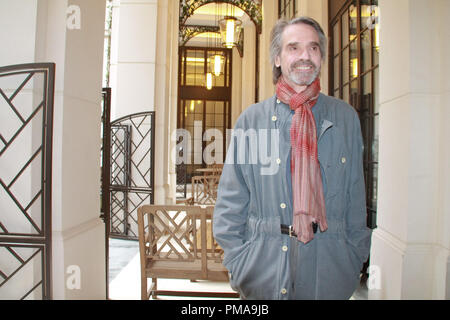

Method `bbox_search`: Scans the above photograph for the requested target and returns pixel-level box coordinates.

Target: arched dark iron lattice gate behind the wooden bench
[110,112,155,239]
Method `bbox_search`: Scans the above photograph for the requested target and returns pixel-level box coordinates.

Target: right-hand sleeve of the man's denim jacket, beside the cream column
[345,112,372,268]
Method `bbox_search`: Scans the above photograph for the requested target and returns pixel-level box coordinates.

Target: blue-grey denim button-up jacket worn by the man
[213,94,371,299]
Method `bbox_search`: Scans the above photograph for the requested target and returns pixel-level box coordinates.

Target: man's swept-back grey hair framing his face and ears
[270,17,327,84]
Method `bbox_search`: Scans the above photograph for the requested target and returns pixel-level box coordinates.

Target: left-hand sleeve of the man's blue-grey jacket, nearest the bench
[213,120,250,272]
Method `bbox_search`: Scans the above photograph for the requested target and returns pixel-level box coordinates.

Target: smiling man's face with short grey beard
[275,23,322,92]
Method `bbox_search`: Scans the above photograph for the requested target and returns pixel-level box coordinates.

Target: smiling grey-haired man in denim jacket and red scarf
[214,17,371,299]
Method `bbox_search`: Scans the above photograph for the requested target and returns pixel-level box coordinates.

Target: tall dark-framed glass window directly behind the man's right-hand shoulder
[329,0,380,228]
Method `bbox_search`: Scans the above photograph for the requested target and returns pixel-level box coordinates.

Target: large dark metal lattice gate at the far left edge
[0,63,55,299]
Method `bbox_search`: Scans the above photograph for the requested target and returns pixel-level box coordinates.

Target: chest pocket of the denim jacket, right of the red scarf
[319,126,351,199]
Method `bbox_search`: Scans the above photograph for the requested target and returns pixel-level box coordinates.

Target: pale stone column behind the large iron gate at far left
[0,0,42,300]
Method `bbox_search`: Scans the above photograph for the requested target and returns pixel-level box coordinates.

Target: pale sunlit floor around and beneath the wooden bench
[109,239,368,300]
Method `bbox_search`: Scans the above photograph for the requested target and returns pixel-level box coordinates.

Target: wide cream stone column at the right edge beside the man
[369,0,450,299]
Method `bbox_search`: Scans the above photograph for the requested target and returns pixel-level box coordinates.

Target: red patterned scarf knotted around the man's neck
[276,76,328,243]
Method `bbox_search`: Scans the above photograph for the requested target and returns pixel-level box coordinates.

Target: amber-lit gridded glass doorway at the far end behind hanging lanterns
[177,46,232,185]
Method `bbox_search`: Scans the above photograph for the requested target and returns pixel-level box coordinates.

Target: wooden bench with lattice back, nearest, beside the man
[138,205,239,300]
